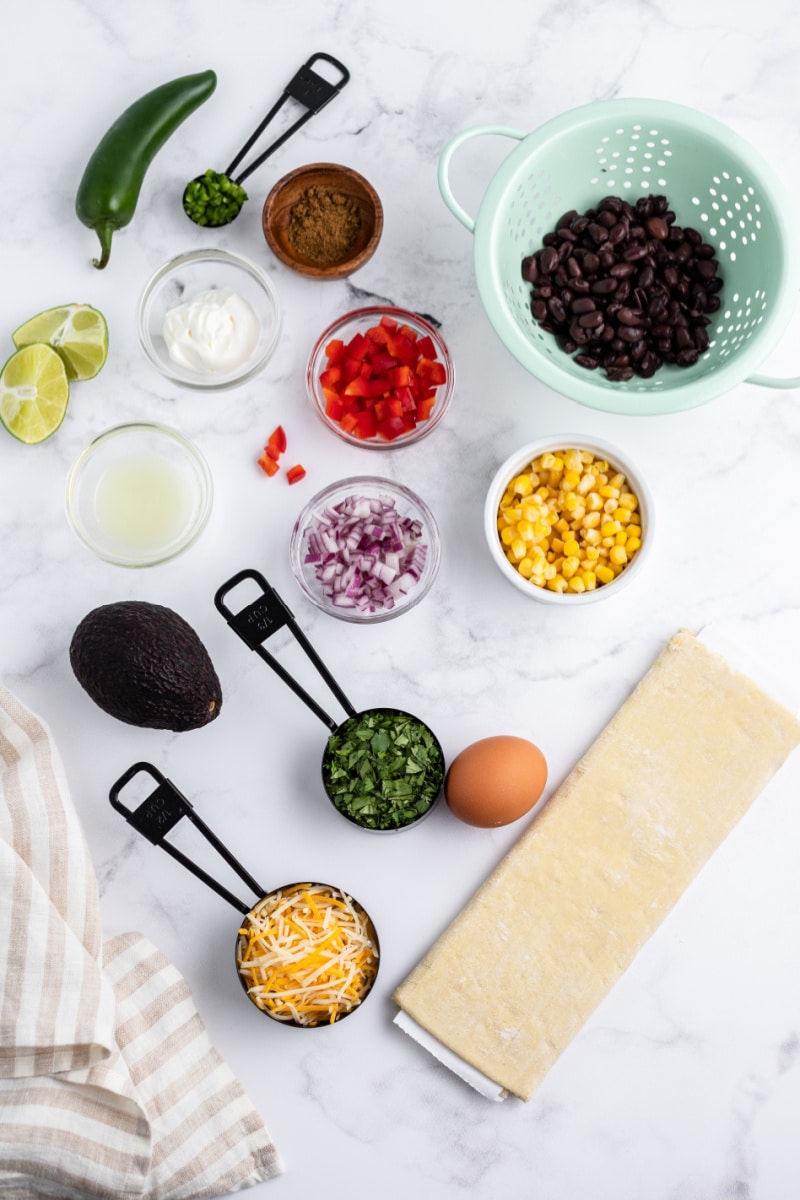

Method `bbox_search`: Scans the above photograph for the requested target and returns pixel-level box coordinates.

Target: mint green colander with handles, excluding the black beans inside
[439,100,800,415]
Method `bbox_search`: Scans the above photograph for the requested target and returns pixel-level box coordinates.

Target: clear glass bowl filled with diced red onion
[290,475,440,623]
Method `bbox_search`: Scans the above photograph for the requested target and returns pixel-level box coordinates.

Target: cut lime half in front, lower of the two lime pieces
[0,342,70,445]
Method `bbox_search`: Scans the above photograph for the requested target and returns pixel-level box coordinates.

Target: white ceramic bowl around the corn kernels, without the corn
[483,433,654,608]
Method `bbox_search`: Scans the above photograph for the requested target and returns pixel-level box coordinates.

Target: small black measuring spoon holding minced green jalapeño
[184,50,350,228]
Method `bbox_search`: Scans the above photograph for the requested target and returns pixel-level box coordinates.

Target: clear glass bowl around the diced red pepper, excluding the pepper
[306,305,456,450]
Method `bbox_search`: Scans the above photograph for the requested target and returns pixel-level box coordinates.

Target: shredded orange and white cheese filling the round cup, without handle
[237,884,378,1025]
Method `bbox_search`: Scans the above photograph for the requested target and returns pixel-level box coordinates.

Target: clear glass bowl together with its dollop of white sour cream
[138,250,282,391]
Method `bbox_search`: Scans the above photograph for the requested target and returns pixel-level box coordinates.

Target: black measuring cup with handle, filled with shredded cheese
[109,762,380,1028]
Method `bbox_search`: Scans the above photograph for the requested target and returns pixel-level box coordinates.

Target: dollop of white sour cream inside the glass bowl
[163,288,261,374]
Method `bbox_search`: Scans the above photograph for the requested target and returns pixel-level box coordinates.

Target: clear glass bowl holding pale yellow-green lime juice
[66,422,213,566]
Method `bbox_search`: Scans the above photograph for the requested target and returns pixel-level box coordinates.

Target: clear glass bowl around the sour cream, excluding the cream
[137,250,282,391]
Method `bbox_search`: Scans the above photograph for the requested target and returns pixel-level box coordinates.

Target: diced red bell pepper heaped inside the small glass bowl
[319,316,447,440]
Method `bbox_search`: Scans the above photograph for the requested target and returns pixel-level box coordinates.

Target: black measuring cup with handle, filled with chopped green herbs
[213,568,445,833]
